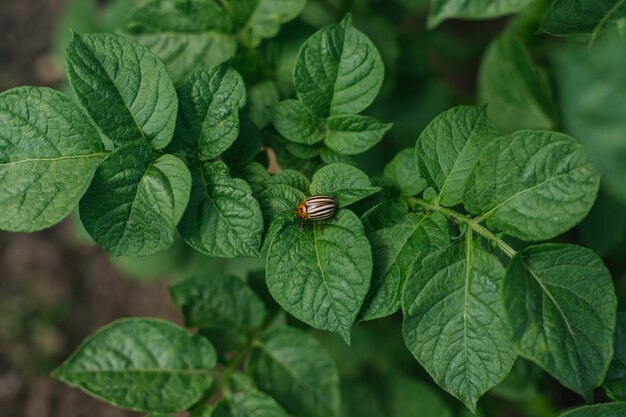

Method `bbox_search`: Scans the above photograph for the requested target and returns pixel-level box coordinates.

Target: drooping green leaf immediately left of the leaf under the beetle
[178,162,263,258]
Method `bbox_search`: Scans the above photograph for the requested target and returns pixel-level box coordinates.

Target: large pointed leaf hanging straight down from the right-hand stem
[402,234,516,412]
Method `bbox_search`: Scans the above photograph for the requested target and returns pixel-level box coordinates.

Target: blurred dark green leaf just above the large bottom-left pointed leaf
[170,274,267,335]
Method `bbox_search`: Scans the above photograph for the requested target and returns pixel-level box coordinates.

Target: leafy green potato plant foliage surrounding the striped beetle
[0,0,626,417]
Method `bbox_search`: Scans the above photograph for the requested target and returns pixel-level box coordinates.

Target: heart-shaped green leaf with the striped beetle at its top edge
[266,210,372,343]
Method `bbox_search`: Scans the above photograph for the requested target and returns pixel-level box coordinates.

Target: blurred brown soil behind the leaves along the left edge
[0,0,180,417]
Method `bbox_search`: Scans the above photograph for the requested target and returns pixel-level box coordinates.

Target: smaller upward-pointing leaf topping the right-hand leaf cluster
[415,106,499,206]
